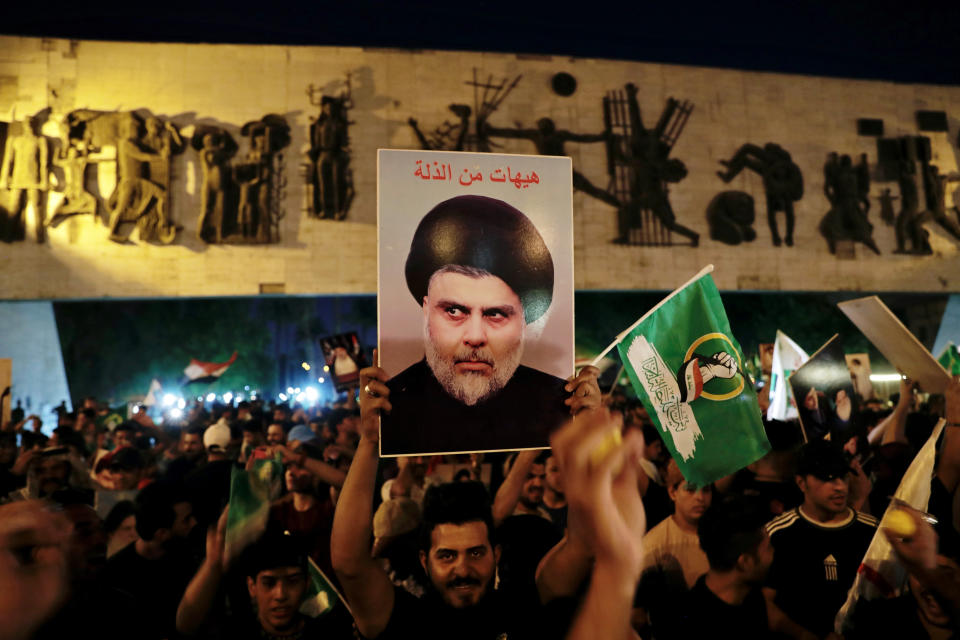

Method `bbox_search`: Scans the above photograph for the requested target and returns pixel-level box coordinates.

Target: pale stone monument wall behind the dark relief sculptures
[0,37,960,299]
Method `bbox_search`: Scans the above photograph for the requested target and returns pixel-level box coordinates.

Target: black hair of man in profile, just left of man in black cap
[697,496,768,571]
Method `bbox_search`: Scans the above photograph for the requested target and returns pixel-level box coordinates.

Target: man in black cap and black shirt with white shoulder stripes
[764,440,877,637]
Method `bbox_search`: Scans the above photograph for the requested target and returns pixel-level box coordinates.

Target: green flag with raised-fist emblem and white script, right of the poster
[611,265,770,486]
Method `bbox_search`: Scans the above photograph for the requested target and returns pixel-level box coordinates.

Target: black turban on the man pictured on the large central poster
[406,196,553,324]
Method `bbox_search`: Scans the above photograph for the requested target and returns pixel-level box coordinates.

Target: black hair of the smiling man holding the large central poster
[420,482,495,552]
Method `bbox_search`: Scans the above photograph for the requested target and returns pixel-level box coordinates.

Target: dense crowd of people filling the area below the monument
[0,367,960,640]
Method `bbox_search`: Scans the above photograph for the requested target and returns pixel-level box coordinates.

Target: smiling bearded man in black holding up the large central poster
[330,367,599,640]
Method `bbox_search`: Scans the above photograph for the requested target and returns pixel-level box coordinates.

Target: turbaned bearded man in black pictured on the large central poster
[382,196,570,454]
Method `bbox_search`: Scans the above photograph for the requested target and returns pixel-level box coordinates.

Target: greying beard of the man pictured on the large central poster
[423,324,523,407]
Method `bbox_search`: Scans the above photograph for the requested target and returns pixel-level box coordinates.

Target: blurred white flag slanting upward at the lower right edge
[834,419,946,635]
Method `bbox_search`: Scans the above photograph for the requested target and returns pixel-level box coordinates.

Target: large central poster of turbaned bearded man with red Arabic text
[376,150,574,456]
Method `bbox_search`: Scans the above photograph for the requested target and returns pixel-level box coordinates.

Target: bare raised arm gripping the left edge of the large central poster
[330,356,394,638]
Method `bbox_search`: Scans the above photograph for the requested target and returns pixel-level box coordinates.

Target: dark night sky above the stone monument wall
[0,0,960,84]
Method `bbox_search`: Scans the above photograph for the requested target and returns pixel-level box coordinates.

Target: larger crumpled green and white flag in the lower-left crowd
[224,460,283,560]
